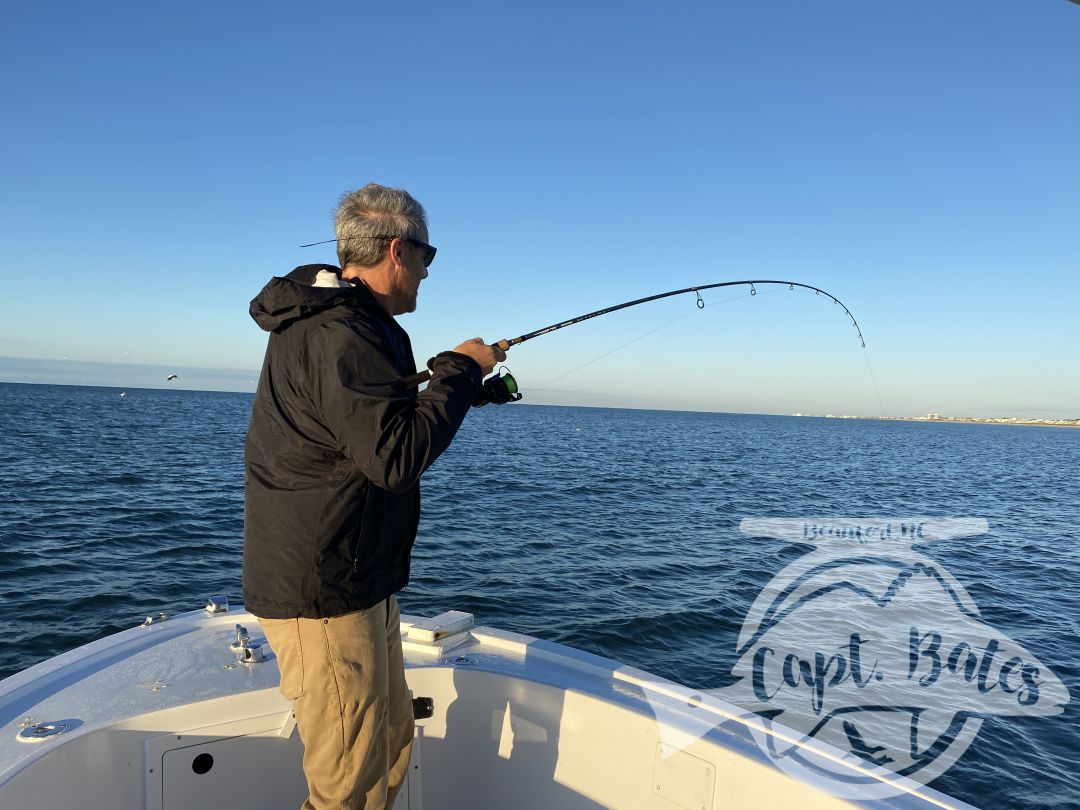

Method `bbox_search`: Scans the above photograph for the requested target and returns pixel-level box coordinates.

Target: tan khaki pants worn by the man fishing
[259,596,414,810]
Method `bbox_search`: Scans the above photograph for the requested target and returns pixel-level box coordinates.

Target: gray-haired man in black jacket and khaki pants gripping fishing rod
[244,184,505,810]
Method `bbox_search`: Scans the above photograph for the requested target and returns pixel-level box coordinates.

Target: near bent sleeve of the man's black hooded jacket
[309,322,482,492]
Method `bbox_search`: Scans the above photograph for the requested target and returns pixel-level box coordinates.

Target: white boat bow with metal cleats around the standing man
[0,596,971,810]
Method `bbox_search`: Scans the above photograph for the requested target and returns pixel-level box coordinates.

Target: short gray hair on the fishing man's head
[334,183,428,268]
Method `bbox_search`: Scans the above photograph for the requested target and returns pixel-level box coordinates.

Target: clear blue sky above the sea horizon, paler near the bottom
[0,0,1080,417]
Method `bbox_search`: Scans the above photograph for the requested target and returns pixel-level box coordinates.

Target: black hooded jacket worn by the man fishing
[244,265,482,619]
